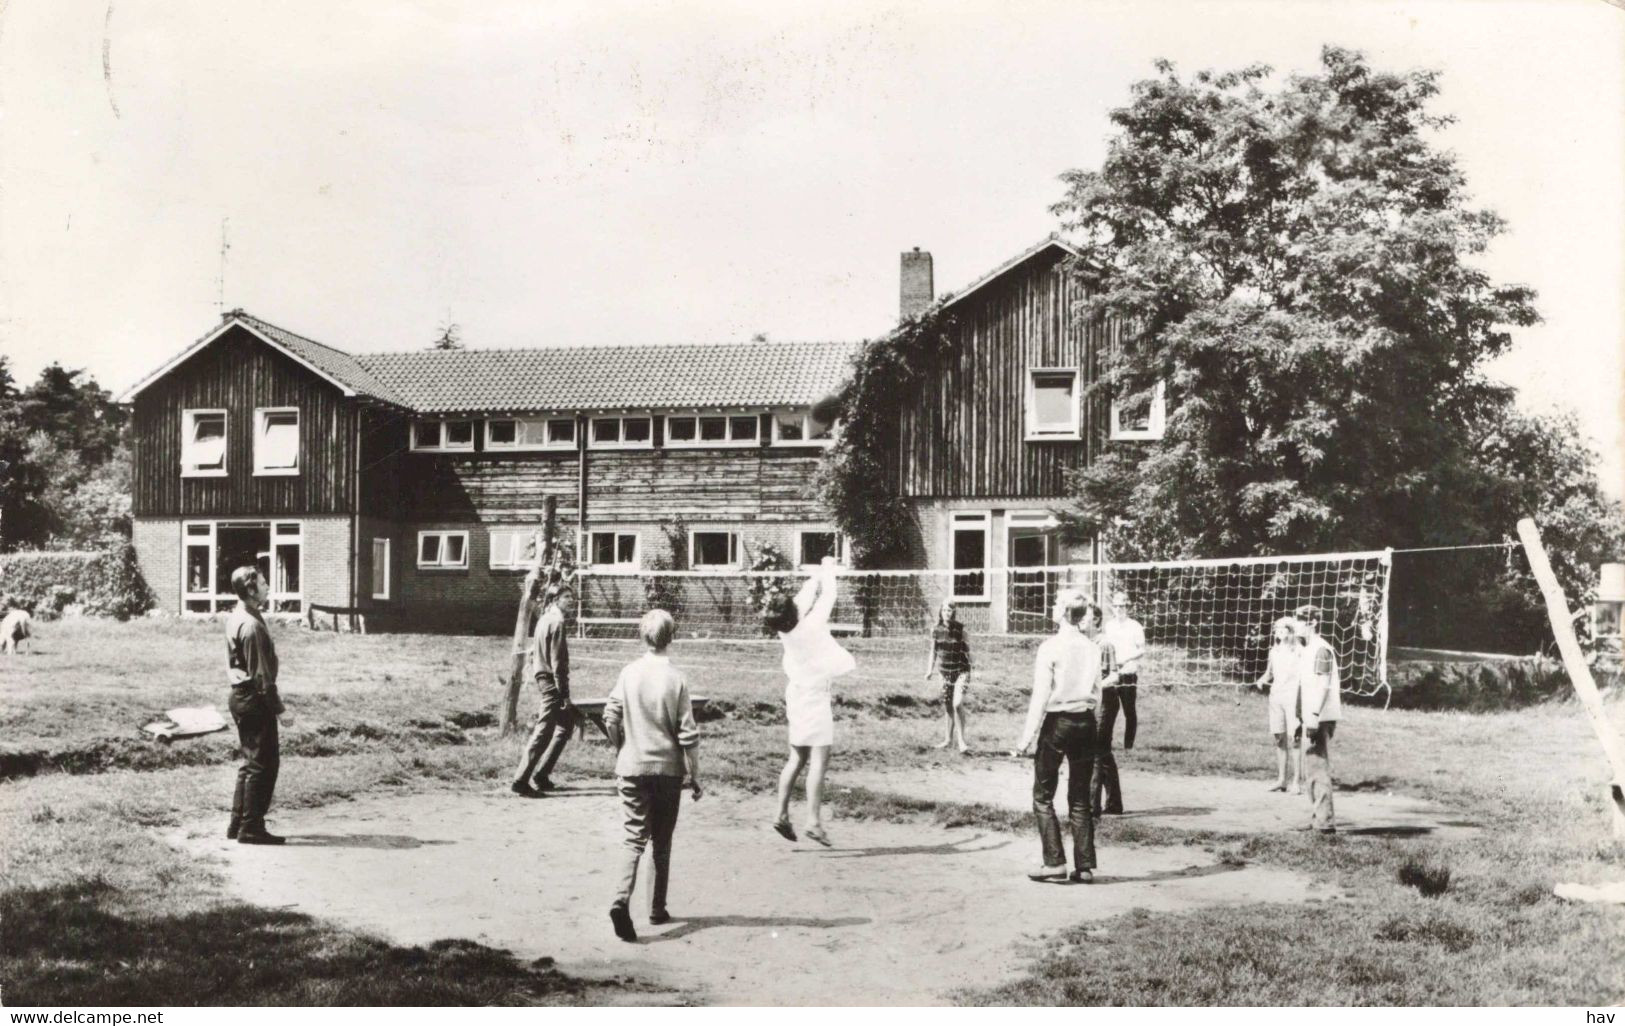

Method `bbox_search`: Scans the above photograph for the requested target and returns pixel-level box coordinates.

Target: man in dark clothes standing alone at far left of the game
[226,566,283,844]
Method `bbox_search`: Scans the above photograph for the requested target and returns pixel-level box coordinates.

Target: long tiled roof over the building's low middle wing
[356,341,856,413]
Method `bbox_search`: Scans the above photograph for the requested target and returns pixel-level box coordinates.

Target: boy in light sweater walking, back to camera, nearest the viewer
[605,610,700,941]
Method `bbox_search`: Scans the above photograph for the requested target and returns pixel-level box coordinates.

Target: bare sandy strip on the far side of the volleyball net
[839,756,1479,837]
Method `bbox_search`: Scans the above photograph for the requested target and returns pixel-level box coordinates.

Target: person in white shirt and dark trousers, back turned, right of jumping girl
[1017,592,1112,883]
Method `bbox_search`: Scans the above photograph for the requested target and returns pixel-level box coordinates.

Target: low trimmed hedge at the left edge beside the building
[0,545,153,620]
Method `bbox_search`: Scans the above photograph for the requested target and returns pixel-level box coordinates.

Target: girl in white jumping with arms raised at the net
[762,556,856,847]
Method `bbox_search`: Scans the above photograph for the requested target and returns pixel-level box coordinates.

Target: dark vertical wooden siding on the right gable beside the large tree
[889,254,1108,498]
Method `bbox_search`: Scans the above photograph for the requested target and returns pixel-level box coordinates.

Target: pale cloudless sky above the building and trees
[0,0,1625,494]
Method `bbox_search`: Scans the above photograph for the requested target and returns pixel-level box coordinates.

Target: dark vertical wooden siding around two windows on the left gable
[130,327,356,519]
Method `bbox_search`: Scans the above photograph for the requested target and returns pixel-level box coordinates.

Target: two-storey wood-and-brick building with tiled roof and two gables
[124,239,1162,629]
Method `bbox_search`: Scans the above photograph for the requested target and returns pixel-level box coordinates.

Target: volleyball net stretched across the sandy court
[575,551,1393,696]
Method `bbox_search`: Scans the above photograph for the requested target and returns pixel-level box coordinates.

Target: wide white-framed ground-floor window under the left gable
[180,520,304,615]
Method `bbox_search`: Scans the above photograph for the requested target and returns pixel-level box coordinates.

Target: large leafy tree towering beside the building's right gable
[1055,47,1619,650]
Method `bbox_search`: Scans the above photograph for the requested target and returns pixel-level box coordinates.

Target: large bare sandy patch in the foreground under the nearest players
[176,777,1336,1005]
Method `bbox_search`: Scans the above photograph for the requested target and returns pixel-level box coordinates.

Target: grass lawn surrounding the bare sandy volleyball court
[0,621,1625,1005]
